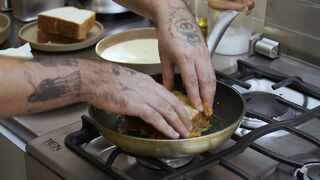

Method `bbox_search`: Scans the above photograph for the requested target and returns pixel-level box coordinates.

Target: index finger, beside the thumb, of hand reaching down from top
[180,63,203,111]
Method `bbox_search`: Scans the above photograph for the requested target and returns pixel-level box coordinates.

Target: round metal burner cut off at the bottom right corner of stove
[294,162,320,180]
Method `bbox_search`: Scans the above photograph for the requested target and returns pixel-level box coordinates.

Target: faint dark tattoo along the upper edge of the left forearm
[26,58,78,67]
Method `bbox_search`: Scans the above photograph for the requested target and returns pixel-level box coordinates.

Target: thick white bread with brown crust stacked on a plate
[38,7,96,40]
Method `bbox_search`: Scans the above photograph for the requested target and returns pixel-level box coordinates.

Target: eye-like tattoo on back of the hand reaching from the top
[168,7,201,46]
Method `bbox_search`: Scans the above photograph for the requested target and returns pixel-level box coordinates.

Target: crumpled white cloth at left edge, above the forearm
[0,43,33,59]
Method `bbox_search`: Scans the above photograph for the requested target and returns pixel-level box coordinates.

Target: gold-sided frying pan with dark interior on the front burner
[89,75,244,158]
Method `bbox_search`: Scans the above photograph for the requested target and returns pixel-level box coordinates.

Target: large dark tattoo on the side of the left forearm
[24,71,81,102]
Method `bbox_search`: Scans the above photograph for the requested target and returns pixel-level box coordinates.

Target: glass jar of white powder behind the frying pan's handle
[208,0,253,55]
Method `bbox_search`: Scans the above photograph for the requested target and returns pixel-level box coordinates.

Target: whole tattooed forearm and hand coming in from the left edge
[0,58,192,138]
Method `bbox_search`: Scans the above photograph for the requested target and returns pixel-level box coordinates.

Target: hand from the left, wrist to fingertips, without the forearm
[85,63,192,138]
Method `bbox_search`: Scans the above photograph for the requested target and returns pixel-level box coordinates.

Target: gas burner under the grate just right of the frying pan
[241,91,294,129]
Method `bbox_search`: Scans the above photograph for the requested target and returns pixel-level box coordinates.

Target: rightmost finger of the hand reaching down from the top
[196,55,216,114]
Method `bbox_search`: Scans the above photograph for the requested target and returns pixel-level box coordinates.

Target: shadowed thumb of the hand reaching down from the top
[161,61,174,90]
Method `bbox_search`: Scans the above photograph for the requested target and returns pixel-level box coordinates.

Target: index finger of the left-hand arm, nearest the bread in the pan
[153,84,192,131]
